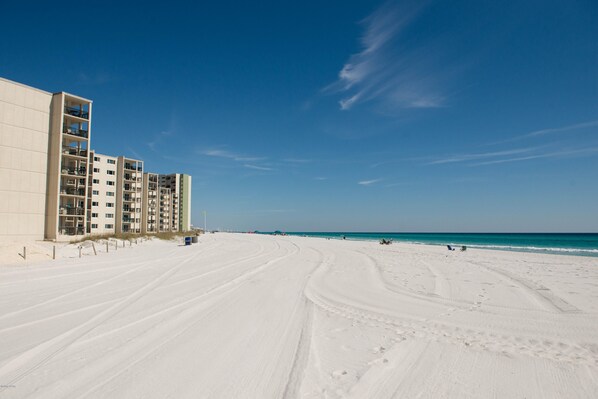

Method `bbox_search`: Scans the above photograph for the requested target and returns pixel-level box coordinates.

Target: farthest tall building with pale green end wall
[160,173,191,231]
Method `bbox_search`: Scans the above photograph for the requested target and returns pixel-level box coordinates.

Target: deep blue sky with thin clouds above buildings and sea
[0,0,598,232]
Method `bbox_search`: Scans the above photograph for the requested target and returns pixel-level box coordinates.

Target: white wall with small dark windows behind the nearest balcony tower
[87,151,118,235]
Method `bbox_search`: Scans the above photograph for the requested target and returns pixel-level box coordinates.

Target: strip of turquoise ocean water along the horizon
[276,232,598,256]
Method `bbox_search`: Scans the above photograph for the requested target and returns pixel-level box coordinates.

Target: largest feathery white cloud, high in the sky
[324,1,449,110]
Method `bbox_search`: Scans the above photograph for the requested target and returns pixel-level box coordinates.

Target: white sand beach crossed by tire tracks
[0,233,598,399]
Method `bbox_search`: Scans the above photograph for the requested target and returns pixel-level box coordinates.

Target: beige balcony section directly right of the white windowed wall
[116,156,143,234]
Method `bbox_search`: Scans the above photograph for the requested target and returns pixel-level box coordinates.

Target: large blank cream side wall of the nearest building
[0,78,52,241]
